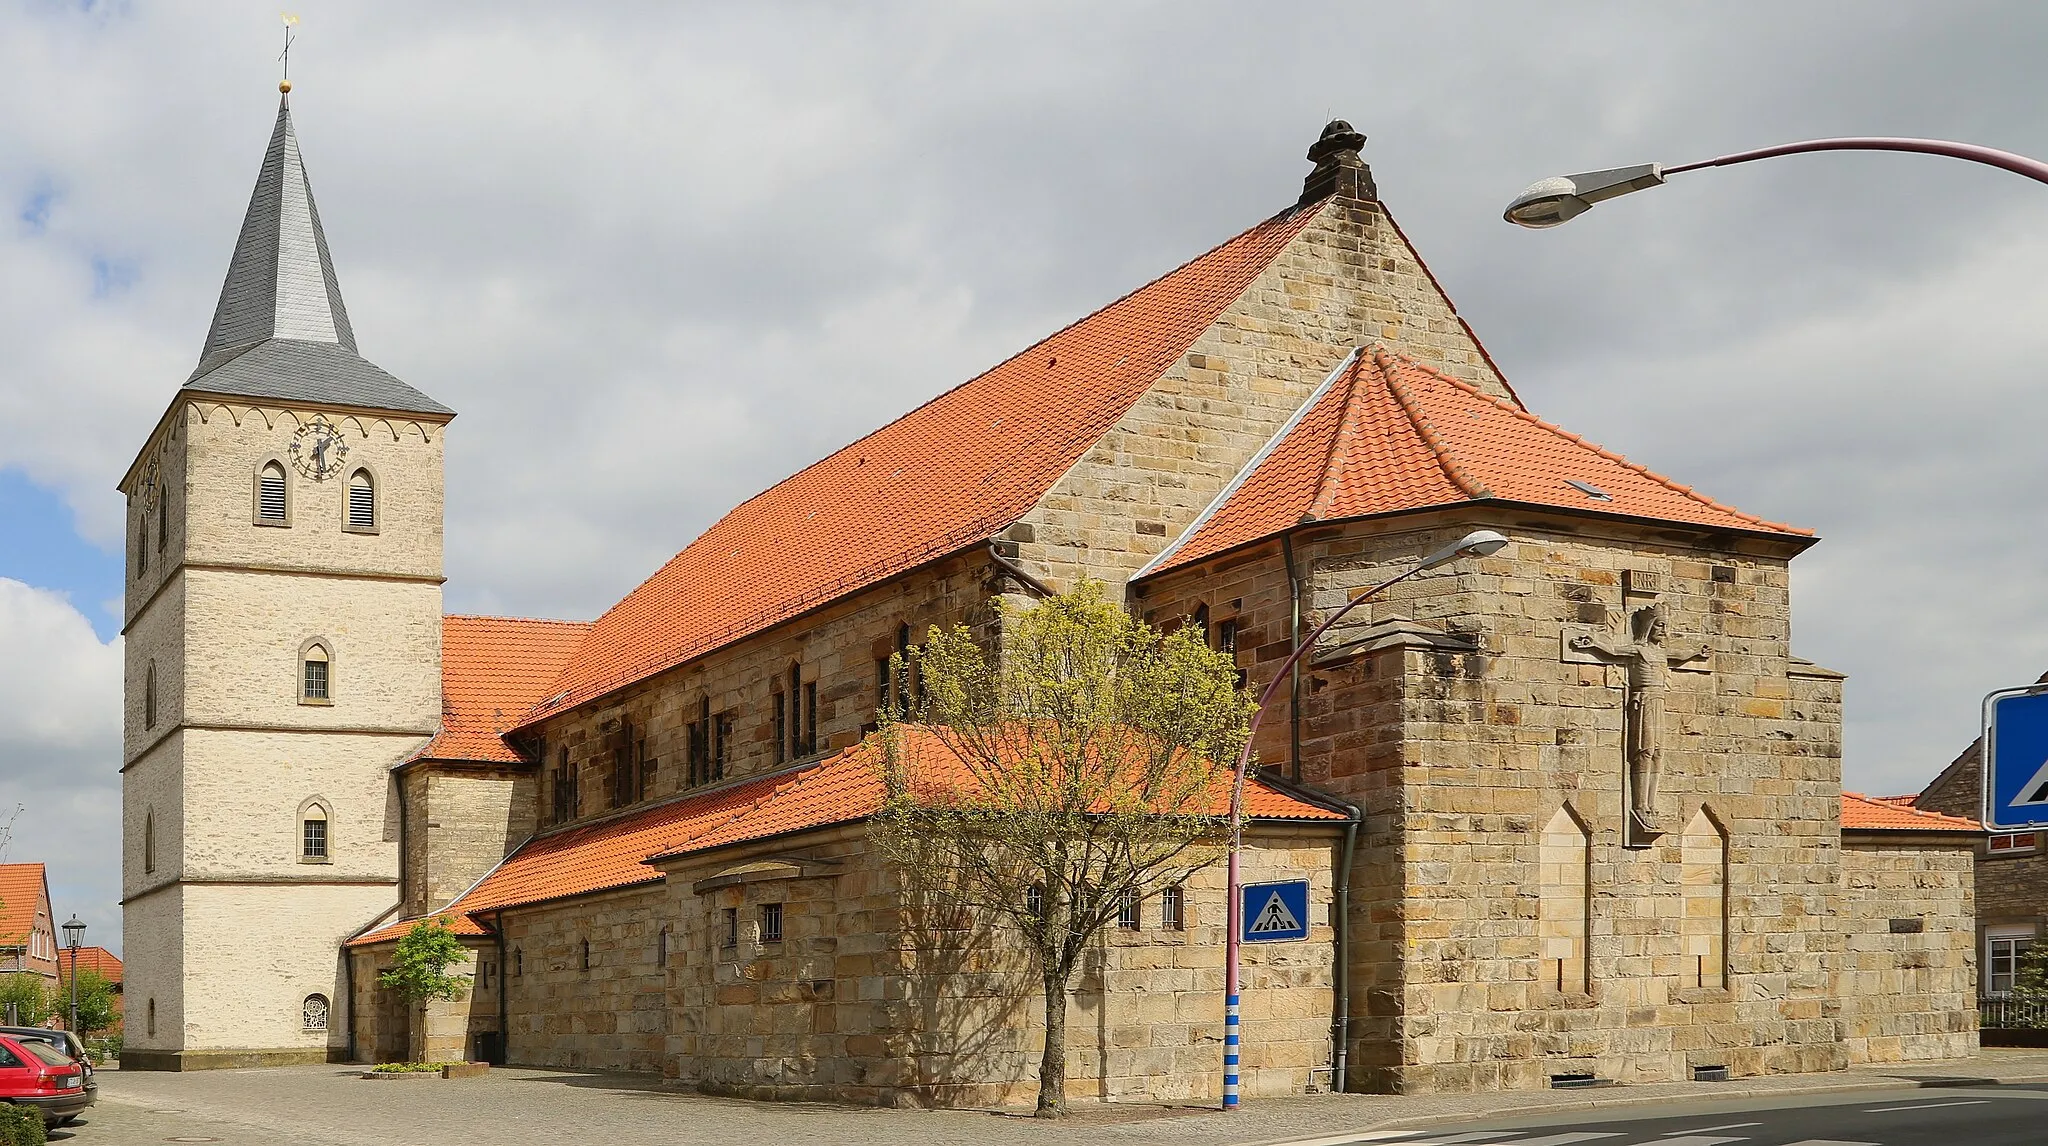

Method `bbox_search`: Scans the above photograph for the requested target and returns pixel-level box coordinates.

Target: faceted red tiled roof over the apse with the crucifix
[1139,337,1808,577]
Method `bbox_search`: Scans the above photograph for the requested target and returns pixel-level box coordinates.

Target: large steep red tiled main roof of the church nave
[528,207,1317,720]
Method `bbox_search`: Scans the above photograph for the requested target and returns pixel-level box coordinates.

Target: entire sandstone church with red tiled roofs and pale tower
[121,94,1976,1105]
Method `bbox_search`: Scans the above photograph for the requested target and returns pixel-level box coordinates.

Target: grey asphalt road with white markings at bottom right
[1303,1087,2048,1146]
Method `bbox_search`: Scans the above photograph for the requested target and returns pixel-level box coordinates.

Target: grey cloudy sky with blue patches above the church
[0,0,2048,941]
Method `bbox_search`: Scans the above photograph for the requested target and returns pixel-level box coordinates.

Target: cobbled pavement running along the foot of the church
[83,1050,2048,1146]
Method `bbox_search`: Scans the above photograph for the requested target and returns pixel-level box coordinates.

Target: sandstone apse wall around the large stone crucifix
[1143,508,1845,1091]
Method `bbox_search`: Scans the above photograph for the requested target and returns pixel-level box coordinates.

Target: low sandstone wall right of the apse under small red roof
[1835,831,1976,1064]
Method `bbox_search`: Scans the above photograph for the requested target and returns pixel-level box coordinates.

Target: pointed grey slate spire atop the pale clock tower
[184,96,455,413]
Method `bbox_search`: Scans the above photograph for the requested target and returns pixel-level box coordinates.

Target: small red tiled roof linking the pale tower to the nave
[414,616,590,763]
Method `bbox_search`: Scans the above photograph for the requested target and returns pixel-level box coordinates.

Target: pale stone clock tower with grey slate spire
[121,100,455,1070]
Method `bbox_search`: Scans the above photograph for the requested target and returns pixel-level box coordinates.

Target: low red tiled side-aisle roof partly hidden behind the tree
[350,729,1346,947]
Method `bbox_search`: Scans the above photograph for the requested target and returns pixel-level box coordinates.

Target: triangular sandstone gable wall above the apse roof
[1012,199,1509,587]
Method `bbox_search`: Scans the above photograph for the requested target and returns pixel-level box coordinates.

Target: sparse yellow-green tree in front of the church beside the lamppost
[870,581,1253,1117]
